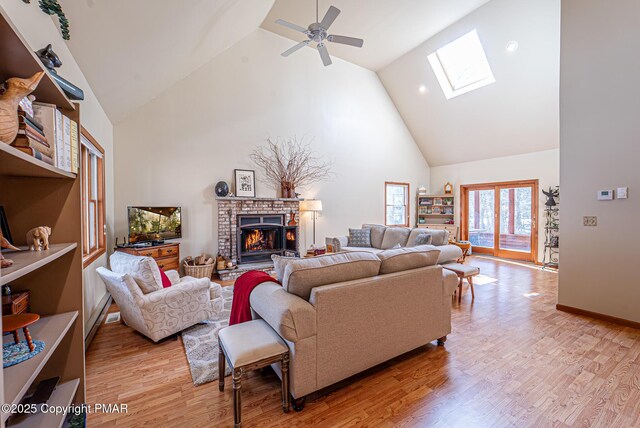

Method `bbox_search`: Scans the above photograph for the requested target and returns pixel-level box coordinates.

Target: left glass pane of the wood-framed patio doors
[467,189,495,248]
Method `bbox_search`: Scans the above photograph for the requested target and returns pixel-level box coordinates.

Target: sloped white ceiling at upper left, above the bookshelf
[54,0,273,123]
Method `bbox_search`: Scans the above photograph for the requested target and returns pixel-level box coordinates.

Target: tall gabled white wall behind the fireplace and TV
[114,29,429,257]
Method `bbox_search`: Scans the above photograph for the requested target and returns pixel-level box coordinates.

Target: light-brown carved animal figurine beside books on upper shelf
[0,71,44,144]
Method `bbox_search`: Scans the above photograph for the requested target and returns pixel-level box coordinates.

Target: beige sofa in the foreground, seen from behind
[250,246,457,401]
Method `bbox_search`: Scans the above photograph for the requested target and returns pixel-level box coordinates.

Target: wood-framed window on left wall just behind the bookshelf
[80,128,106,267]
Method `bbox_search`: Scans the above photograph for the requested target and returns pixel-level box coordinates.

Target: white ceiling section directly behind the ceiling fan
[262,0,489,71]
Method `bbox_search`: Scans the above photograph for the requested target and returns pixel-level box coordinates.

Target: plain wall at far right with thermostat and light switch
[558,0,640,322]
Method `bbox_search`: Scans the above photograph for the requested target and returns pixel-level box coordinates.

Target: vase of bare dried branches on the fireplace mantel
[250,137,333,198]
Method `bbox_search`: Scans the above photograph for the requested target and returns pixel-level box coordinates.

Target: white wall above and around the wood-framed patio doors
[429,149,560,261]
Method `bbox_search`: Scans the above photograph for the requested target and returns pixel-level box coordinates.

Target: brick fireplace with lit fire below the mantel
[216,197,301,265]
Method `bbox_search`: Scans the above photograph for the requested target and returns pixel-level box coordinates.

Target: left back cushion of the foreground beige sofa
[282,251,380,300]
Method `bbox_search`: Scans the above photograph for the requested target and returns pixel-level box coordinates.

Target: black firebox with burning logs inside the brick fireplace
[236,214,298,264]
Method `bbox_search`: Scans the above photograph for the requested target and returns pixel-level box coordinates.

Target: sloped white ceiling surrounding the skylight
[378,0,560,166]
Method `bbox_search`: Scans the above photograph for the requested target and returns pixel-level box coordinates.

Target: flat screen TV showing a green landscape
[128,207,182,244]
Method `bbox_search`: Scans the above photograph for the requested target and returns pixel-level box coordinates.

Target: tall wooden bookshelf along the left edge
[0,8,85,427]
